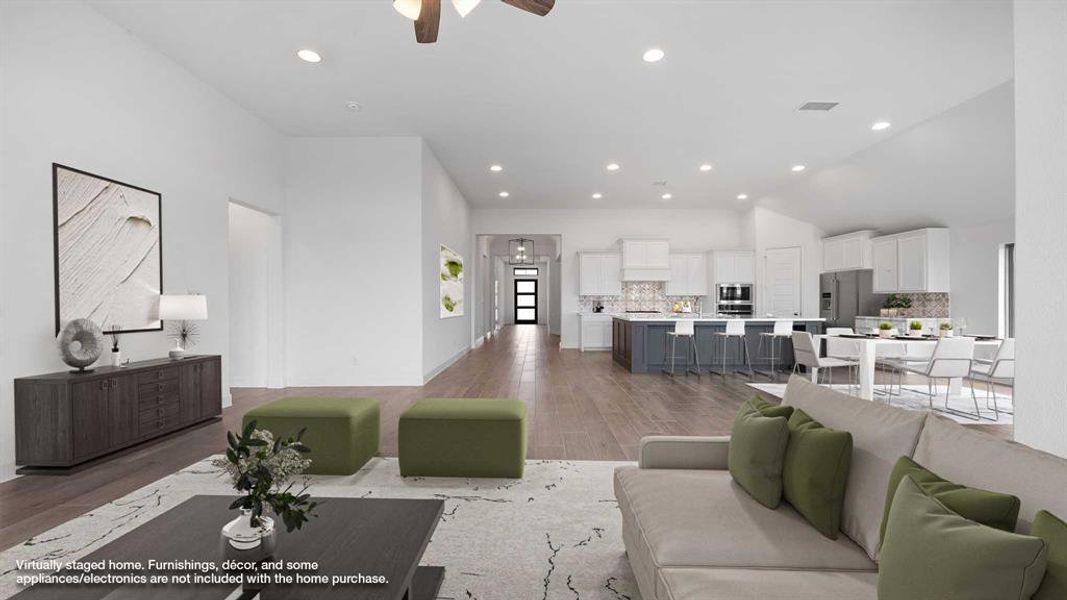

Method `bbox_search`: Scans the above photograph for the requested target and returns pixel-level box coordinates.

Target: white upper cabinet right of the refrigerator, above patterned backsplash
[871,227,951,294]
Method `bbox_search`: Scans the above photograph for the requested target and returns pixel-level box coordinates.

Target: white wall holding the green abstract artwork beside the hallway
[419,142,477,380]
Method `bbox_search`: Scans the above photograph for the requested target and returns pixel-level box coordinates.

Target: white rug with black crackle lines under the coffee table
[0,458,640,600]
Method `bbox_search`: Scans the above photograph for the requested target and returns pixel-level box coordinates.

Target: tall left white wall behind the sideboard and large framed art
[0,2,283,479]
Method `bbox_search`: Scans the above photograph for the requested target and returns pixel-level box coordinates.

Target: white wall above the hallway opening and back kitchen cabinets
[471,209,742,348]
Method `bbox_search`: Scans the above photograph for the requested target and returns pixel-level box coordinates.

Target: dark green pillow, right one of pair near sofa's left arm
[782,409,853,539]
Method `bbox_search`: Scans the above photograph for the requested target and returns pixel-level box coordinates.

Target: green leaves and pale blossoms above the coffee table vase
[212,421,318,532]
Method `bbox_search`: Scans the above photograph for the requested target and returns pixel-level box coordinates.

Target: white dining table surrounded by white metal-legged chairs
[811,333,1001,400]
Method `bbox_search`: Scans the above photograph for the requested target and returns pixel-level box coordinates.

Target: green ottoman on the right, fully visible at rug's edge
[399,398,526,477]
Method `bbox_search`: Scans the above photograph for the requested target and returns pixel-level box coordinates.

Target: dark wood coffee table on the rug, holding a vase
[15,495,445,600]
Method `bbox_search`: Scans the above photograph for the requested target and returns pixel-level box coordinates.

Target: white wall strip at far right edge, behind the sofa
[1015,0,1067,456]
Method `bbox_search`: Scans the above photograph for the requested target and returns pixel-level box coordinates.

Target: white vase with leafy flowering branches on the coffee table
[212,421,317,562]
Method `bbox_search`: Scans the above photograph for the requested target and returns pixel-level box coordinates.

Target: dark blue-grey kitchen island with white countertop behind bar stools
[611,315,825,373]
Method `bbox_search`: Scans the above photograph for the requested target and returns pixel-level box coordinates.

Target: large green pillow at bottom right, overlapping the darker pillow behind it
[878,475,1048,600]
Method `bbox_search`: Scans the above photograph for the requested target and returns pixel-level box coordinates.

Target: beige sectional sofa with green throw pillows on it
[615,377,1067,600]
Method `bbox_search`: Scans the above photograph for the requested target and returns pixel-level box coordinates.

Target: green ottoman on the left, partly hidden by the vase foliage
[244,398,379,475]
